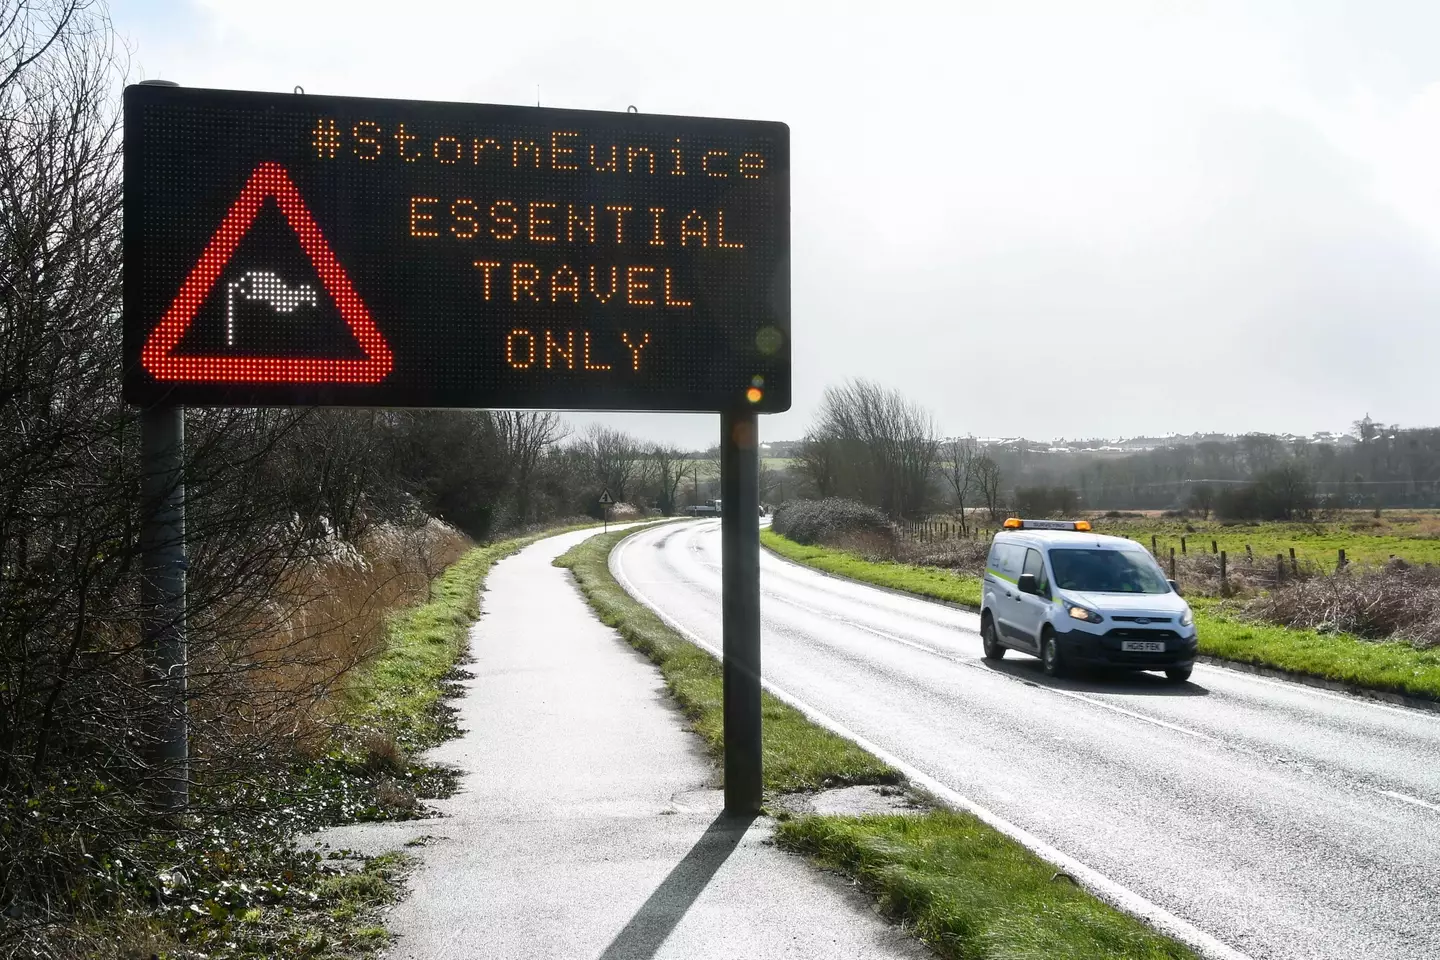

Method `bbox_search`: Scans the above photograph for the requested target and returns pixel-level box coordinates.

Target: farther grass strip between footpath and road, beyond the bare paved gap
[554,530,900,793]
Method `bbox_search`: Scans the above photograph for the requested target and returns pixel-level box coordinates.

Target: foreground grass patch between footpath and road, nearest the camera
[778,810,1195,960]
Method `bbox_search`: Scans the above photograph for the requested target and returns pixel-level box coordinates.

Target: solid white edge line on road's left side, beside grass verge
[608,538,1251,960]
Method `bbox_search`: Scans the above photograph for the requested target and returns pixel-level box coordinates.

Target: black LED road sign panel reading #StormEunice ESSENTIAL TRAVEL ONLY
[124,85,791,413]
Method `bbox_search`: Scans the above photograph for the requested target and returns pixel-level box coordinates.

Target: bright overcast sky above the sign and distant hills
[111,0,1440,446]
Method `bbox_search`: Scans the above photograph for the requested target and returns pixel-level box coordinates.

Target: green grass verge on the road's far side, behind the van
[760,530,1440,701]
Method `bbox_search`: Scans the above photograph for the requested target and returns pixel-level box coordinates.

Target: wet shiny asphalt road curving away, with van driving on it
[611,521,1440,960]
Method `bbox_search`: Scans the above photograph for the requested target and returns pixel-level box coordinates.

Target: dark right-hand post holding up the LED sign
[720,410,765,816]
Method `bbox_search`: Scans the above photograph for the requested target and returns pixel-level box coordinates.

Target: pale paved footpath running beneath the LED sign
[309,531,930,960]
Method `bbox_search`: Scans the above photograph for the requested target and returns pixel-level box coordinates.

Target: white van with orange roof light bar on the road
[981,518,1197,682]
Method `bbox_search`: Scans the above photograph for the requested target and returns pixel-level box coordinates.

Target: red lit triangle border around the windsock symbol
[140,161,395,384]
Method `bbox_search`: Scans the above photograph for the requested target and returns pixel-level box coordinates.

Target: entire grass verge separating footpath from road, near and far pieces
[573,531,1194,960]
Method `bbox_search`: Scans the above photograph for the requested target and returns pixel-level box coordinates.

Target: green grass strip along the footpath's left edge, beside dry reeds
[344,524,593,750]
